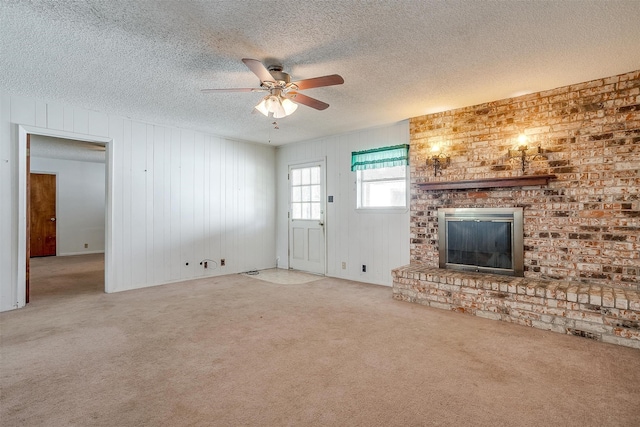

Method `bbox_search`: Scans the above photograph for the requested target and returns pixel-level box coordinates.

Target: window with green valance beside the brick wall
[351,145,409,209]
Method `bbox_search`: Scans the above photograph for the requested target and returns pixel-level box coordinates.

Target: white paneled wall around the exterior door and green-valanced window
[276,121,409,286]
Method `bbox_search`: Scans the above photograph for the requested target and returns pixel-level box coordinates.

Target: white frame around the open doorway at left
[16,125,114,308]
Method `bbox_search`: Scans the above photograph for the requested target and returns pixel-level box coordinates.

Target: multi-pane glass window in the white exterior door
[290,166,322,220]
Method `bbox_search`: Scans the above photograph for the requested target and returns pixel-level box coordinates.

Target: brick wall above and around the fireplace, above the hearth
[410,70,640,290]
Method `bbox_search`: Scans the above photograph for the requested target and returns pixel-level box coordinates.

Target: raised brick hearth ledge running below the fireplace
[392,264,640,349]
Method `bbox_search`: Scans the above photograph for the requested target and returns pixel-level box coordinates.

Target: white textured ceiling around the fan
[0,0,640,145]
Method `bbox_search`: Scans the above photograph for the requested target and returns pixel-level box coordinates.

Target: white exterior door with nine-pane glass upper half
[289,162,325,274]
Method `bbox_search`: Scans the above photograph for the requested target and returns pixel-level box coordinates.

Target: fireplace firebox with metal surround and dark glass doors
[438,208,524,276]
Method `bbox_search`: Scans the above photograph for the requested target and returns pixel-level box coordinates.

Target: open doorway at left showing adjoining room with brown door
[26,135,106,302]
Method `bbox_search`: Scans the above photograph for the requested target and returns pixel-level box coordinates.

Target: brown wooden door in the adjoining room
[29,173,56,257]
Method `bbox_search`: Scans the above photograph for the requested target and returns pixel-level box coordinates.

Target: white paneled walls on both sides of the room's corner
[0,95,409,311]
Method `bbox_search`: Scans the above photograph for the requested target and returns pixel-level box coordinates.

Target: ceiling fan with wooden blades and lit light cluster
[202,58,344,119]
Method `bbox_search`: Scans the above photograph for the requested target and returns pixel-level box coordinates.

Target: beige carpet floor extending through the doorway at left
[0,256,640,426]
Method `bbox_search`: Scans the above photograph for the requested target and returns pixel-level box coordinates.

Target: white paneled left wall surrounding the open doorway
[0,95,276,311]
